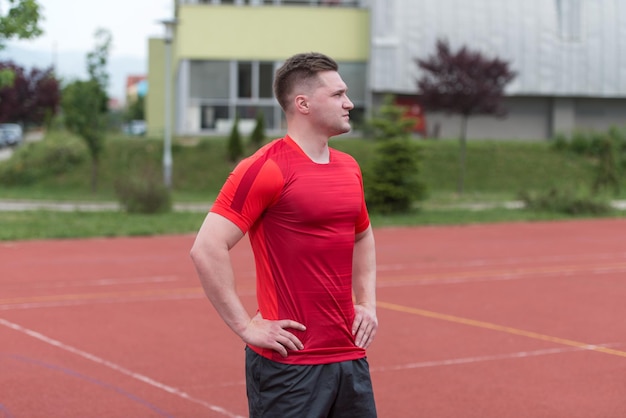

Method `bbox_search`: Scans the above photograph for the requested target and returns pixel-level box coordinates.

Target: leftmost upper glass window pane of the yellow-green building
[189,61,230,99]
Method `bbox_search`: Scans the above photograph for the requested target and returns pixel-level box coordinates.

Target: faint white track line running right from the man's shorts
[371,344,617,372]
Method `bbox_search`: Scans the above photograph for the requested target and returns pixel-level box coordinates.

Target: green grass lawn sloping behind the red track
[0,132,624,240]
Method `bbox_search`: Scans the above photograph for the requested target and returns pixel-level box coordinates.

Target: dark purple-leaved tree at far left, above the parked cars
[0,62,61,125]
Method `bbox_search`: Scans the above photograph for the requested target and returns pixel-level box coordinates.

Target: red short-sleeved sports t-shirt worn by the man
[211,136,370,364]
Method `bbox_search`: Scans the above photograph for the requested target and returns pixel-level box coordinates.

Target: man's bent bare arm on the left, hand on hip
[191,212,305,357]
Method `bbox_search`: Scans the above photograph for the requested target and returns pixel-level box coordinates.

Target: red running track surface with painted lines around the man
[0,219,626,418]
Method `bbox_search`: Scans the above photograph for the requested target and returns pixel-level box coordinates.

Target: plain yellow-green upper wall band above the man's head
[176,5,370,62]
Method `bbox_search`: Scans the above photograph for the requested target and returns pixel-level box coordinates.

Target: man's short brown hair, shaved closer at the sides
[274,52,339,111]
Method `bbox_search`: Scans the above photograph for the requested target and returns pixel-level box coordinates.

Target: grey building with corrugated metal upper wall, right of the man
[369,0,626,139]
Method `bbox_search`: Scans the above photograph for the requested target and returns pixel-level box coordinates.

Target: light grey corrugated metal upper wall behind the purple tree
[371,0,626,97]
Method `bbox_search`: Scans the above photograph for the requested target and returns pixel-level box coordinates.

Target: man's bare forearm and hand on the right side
[352,225,378,348]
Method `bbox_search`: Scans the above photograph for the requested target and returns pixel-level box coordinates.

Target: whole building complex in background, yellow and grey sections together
[147,0,626,139]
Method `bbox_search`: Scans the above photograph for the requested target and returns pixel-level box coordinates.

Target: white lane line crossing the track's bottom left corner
[0,318,245,418]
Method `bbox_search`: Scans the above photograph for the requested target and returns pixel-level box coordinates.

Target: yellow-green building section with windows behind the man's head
[147,0,370,135]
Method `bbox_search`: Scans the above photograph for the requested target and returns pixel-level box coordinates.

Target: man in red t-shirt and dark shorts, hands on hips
[191,53,378,418]
